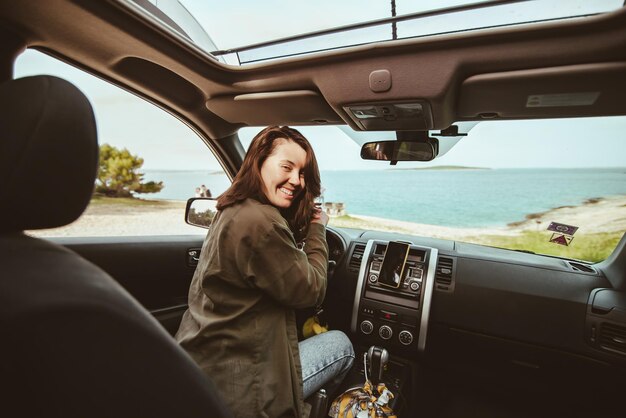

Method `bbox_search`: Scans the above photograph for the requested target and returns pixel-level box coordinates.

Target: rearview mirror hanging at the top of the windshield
[361,138,439,161]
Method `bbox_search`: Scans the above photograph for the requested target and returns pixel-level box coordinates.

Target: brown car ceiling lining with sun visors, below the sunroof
[0,0,626,142]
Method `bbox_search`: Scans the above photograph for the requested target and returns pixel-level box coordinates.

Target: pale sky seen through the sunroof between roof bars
[177,0,623,63]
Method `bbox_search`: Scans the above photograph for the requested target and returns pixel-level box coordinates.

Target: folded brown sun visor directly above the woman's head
[206,90,343,126]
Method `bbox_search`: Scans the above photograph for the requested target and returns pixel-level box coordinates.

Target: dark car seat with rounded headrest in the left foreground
[0,76,230,418]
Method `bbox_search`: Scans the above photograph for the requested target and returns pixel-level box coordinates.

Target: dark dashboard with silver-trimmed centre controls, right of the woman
[326,227,626,372]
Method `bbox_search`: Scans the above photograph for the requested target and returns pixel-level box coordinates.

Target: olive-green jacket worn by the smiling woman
[176,199,328,418]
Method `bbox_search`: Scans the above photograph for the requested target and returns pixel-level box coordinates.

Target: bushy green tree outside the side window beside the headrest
[96,144,164,197]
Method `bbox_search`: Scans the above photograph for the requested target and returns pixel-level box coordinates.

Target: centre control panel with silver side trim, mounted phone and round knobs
[351,240,437,351]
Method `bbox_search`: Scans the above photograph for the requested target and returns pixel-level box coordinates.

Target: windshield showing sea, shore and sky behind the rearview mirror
[240,117,626,262]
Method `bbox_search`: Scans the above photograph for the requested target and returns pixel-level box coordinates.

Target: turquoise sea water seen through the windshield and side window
[143,168,626,227]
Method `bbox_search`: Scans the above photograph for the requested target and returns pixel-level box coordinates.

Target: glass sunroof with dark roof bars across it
[126,0,624,65]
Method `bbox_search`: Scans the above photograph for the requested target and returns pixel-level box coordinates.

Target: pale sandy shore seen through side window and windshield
[32,196,626,239]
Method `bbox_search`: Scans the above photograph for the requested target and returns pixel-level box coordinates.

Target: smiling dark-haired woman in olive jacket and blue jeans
[176,126,354,417]
